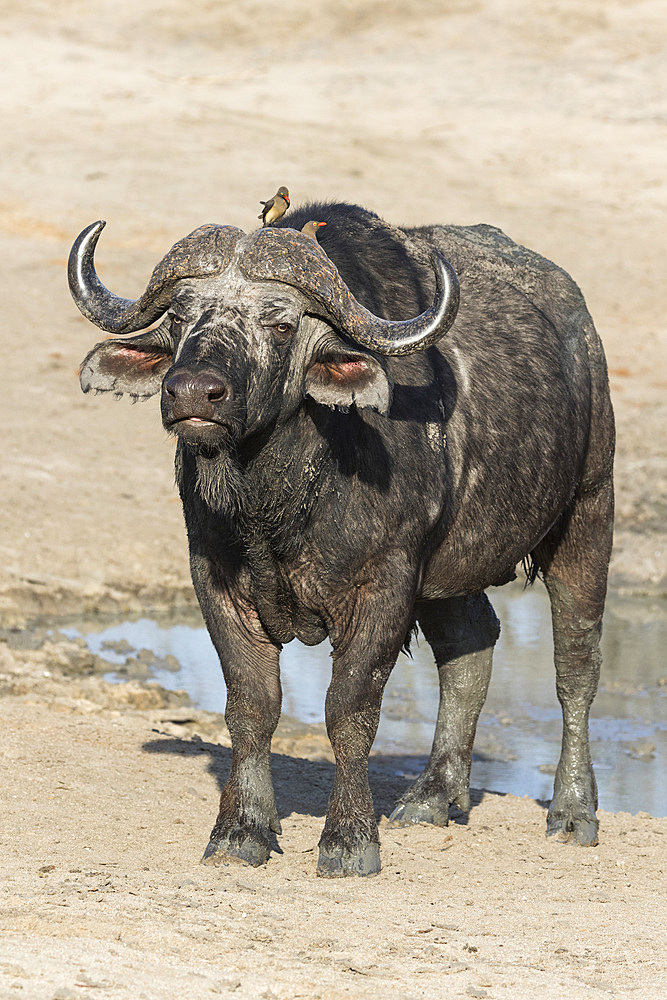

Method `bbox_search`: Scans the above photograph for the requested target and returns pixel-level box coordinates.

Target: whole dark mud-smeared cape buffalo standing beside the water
[69,204,614,875]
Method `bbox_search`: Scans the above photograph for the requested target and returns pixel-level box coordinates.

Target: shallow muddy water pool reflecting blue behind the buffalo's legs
[63,584,667,816]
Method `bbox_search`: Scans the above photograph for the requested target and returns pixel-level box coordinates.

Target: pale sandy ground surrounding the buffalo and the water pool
[0,0,667,1000]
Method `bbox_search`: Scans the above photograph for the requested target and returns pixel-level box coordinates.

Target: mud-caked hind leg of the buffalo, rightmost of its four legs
[533,482,614,846]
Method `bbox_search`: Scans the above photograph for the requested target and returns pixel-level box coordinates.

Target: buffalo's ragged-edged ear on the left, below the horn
[80,323,174,399]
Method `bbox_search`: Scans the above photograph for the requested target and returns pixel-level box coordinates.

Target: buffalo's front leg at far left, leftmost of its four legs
[193,560,282,866]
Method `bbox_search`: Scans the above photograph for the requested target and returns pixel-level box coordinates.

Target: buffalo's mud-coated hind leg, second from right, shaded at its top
[389,593,500,826]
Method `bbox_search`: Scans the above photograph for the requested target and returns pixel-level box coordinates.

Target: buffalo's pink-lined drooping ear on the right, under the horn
[306,351,392,414]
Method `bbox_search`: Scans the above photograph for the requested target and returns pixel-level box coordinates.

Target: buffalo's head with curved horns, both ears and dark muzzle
[69,222,459,450]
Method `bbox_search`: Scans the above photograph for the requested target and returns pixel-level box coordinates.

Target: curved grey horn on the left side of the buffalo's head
[67,221,245,334]
